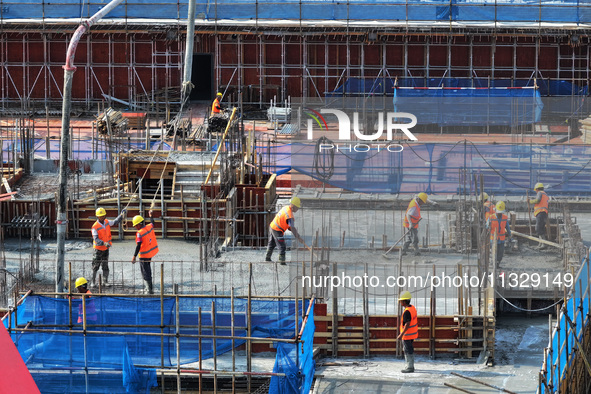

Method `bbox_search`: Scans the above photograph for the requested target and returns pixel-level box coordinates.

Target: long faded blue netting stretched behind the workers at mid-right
[270,142,591,196]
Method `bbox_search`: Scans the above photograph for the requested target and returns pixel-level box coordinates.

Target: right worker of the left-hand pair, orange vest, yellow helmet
[131,209,158,294]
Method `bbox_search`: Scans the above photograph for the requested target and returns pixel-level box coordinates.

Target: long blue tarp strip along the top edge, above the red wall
[0,0,591,25]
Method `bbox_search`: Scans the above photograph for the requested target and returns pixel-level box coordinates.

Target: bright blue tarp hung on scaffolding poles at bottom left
[4,296,314,393]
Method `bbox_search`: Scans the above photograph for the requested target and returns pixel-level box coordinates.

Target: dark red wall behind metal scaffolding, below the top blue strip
[0,29,591,110]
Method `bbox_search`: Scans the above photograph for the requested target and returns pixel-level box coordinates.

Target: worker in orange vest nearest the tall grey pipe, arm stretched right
[90,208,127,287]
